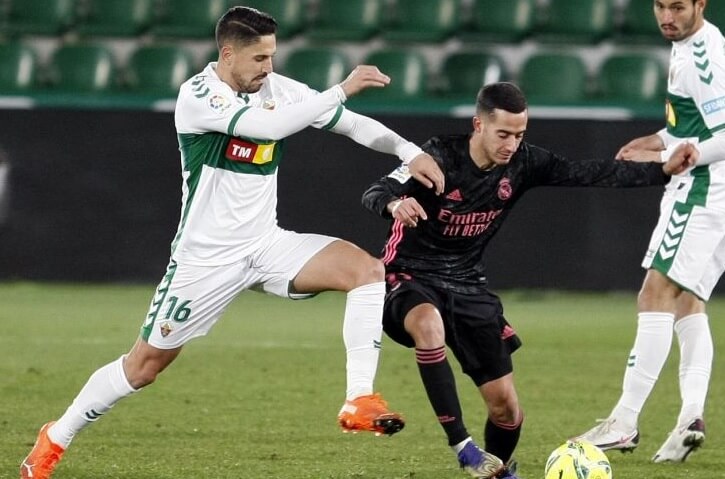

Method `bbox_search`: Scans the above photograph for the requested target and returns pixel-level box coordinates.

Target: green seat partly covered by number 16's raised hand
[360,48,428,100]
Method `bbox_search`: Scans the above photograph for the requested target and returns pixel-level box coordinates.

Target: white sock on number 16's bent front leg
[342,281,385,400]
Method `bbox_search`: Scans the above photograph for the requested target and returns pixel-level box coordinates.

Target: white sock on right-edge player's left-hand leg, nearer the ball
[611,312,675,429]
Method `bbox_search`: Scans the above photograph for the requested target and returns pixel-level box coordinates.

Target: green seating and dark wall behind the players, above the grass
[0,0,725,290]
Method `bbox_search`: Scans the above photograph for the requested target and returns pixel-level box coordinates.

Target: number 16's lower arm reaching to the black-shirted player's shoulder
[329,109,445,194]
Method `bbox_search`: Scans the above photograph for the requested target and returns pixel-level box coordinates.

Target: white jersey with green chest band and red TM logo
[171,62,344,266]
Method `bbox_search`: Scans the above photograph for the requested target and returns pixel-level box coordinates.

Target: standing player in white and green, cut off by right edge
[580,0,725,462]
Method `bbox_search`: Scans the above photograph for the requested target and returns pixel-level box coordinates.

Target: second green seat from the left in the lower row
[46,44,117,93]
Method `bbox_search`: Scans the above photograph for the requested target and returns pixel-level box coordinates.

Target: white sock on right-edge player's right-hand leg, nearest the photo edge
[675,313,713,426]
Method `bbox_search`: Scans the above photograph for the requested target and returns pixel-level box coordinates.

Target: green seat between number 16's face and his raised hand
[282,47,350,91]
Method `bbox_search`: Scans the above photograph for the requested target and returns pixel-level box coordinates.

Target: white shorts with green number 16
[141,229,337,349]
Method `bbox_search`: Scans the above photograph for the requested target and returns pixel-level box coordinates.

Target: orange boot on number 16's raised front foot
[337,393,405,436]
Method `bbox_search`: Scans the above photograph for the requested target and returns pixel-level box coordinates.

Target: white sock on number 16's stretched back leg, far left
[48,356,137,449]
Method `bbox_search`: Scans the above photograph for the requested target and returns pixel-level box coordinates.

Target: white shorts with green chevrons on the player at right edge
[642,177,725,301]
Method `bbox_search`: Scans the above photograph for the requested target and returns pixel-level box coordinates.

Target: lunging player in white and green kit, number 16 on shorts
[20,7,443,479]
